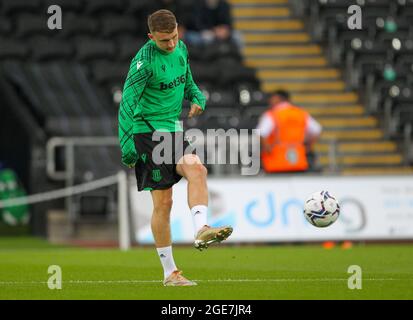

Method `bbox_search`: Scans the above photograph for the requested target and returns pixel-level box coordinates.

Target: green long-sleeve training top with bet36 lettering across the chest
[118,40,205,165]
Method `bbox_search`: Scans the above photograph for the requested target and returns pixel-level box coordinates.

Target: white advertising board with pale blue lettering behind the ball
[131,176,413,243]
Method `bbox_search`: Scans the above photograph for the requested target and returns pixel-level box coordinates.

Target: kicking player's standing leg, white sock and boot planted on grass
[151,188,196,286]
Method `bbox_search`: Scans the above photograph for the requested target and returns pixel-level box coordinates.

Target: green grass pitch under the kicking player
[0,238,413,300]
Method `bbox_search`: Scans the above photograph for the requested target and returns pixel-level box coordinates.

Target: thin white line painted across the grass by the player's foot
[0,278,413,286]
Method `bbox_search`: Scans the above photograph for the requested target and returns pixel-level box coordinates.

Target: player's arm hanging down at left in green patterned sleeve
[118,59,152,167]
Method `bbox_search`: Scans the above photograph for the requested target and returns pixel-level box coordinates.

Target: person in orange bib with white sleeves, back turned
[257,90,322,173]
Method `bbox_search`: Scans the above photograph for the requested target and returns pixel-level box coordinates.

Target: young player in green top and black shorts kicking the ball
[119,10,232,286]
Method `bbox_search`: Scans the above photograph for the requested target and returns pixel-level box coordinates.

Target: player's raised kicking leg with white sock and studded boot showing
[176,154,233,250]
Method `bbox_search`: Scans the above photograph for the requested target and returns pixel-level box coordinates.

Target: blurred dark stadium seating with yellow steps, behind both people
[0,0,413,234]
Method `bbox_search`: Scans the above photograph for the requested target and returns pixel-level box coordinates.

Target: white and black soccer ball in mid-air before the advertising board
[304,191,340,228]
